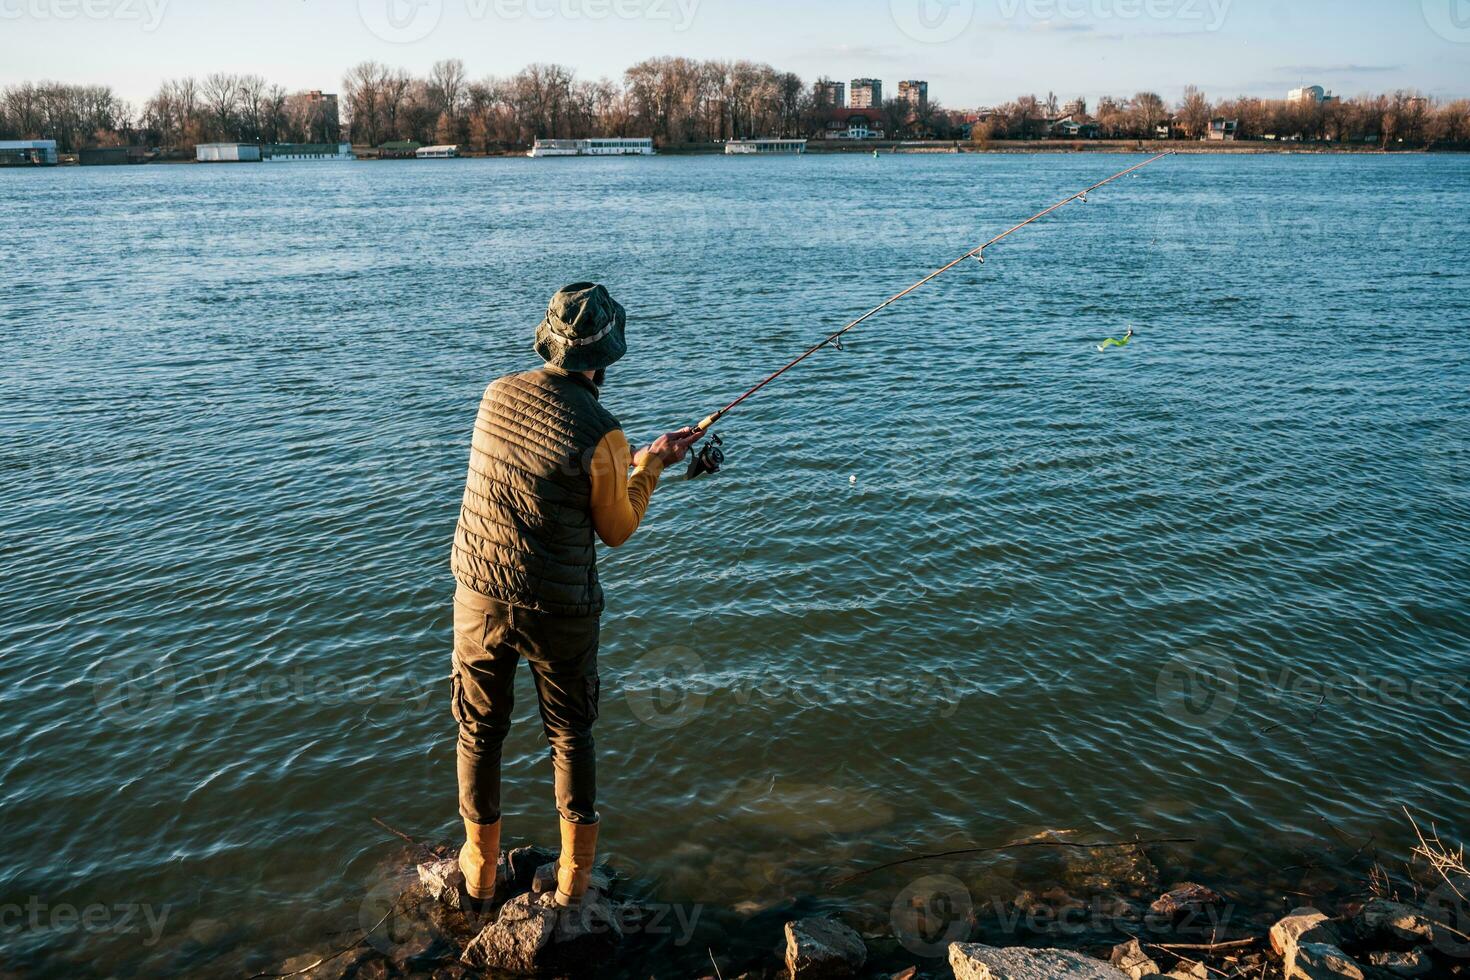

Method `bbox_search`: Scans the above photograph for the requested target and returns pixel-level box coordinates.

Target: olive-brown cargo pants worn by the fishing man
[451,586,600,823]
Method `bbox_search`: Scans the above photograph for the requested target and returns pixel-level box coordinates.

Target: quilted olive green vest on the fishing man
[450,367,619,616]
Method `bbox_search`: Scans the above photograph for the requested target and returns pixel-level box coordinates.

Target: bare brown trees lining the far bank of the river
[0,57,1470,153]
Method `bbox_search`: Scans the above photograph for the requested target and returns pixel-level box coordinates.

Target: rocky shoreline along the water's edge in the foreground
[257,840,1470,980]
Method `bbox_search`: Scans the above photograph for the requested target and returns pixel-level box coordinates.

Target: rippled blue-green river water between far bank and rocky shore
[0,154,1470,976]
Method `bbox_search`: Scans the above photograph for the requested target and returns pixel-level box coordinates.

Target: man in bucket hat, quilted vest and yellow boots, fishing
[450,282,704,905]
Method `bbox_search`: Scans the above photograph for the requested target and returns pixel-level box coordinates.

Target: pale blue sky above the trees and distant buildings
[0,0,1470,109]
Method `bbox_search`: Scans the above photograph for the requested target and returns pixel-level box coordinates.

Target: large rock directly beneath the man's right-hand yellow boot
[460,892,623,973]
